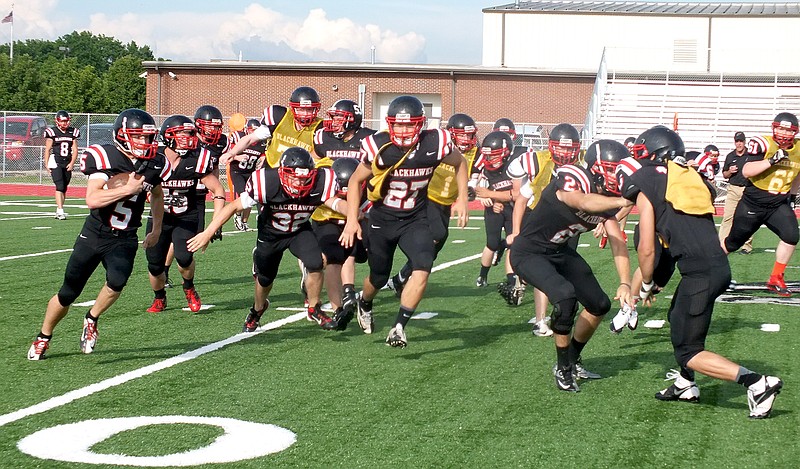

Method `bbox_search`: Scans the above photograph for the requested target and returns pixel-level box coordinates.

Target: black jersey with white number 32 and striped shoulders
[241,168,339,236]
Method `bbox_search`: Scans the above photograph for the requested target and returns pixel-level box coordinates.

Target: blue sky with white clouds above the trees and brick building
[0,0,490,65]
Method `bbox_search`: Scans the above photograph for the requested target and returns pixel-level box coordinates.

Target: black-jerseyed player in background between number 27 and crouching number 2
[475,130,517,287]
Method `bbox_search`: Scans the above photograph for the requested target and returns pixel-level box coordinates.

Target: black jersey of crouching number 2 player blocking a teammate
[514,165,619,249]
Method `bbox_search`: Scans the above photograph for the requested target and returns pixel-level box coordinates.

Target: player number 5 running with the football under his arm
[28,109,171,360]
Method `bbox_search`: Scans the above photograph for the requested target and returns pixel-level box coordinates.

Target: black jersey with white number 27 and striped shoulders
[361,129,453,218]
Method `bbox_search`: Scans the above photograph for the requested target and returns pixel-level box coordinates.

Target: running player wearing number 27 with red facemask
[341,96,468,347]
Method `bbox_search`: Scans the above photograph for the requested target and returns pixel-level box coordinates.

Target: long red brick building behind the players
[144,61,595,135]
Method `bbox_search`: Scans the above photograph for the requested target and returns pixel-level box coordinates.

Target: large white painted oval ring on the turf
[17,415,297,467]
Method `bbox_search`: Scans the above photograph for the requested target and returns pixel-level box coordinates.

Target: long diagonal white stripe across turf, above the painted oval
[0,254,481,427]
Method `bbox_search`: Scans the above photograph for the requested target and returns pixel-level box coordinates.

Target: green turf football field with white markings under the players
[0,197,800,468]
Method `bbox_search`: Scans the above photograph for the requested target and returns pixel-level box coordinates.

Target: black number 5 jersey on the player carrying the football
[80,145,172,231]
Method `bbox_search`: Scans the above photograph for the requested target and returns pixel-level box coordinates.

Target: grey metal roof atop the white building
[482,0,800,17]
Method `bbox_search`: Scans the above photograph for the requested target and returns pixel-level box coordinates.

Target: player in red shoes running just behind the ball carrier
[145,114,225,313]
